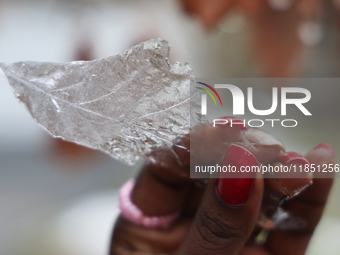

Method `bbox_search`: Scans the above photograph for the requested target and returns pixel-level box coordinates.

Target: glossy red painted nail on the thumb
[216,144,258,206]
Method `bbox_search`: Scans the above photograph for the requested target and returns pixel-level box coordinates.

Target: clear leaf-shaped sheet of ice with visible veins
[0,38,202,164]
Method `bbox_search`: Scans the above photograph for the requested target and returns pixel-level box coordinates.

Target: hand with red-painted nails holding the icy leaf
[110,120,334,255]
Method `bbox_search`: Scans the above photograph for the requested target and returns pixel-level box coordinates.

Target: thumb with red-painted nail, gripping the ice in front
[179,145,263,255]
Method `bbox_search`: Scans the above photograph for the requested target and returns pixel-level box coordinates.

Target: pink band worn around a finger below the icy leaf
[119,179,179,229]
